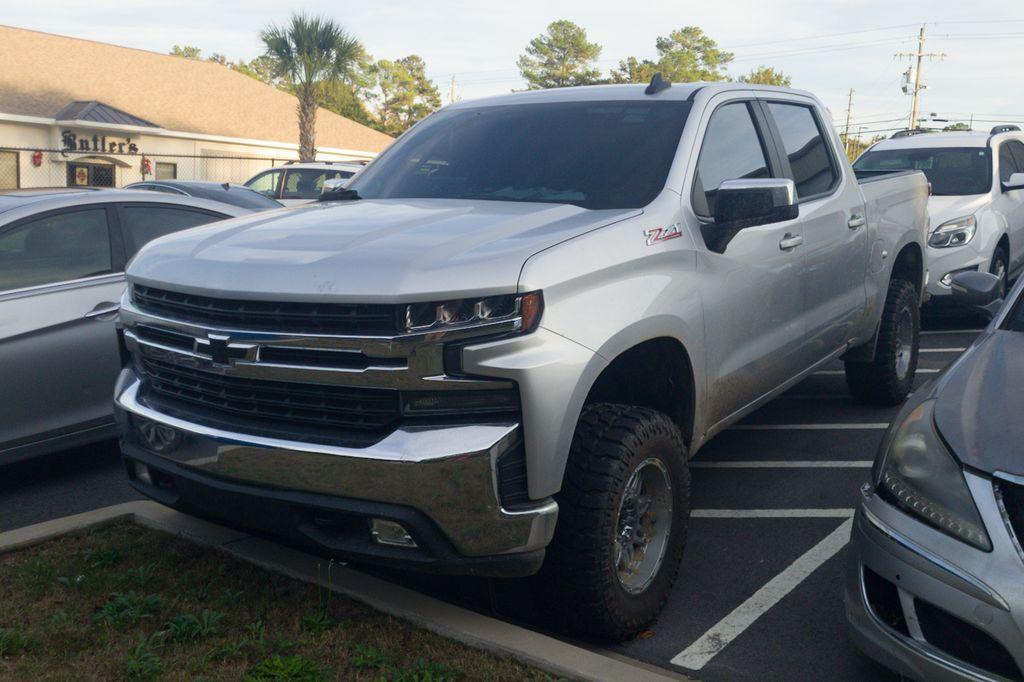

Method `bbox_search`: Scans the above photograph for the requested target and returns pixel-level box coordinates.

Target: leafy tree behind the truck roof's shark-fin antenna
[611,26,733,83]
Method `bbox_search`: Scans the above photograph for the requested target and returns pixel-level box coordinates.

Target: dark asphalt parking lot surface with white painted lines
[0,318,979,680]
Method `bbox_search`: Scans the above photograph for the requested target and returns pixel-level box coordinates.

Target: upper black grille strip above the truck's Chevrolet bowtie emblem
[132,284,403,335]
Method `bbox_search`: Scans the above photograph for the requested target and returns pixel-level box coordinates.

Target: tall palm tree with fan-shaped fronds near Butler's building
[260,13,362,161]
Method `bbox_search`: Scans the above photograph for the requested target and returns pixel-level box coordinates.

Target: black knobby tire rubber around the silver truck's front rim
[537,403,690,642]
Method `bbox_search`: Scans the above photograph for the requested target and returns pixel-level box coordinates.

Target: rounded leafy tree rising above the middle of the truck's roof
[516,19,601,90]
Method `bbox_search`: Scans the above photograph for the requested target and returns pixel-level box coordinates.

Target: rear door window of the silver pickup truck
[768,101,839,199]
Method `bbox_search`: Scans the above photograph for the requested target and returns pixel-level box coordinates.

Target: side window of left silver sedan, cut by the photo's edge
[0,208,113,291]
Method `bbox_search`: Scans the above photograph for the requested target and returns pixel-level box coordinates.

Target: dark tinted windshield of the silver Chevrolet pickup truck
[349,101,690,209]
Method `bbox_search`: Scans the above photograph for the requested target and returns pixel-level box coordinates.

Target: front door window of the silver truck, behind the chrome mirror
[692,101,769,217]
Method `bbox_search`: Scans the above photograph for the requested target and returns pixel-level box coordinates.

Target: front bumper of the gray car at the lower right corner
[846,474,1024,680]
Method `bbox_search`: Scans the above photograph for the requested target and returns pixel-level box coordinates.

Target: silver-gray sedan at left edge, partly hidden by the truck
[0,188,250,464]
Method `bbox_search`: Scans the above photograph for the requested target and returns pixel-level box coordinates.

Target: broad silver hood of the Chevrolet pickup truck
[128,199,642,302]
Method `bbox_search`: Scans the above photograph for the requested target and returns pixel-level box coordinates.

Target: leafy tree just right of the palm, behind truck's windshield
[367,54,441,135]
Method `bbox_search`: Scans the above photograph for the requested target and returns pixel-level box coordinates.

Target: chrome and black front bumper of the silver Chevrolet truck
[115,369,558,576]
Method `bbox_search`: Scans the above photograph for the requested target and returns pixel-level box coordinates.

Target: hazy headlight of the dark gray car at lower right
[879,399,992,552]
